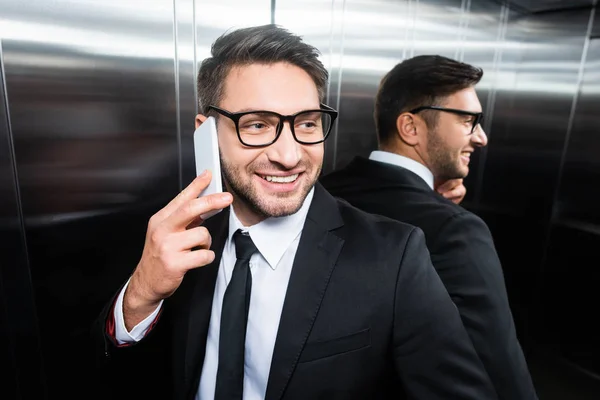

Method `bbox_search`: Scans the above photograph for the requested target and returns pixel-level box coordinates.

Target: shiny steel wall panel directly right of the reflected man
[475,10,590,346]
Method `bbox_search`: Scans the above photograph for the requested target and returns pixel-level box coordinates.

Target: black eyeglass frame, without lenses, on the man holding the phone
[206,103,338,147]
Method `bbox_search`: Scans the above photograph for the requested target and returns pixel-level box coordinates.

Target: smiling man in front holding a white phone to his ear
[94,25,496,400]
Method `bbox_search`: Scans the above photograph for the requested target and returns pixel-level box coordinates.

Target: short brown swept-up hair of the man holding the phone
[197,24,329,114]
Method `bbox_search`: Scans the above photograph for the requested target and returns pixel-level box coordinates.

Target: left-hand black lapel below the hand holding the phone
[178,209,229,398]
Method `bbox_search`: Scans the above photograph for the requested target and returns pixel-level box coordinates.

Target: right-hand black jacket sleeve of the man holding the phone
[393,228,497,400]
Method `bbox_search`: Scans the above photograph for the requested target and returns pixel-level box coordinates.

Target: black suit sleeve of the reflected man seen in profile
[430,213,537,400]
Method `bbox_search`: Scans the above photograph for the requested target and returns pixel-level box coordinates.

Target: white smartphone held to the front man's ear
[194,117,223,219]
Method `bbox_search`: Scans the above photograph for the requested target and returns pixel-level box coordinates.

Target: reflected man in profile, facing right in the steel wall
[321,55,537,400]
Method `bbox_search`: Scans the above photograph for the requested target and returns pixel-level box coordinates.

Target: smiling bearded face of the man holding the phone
[202,63,324,223]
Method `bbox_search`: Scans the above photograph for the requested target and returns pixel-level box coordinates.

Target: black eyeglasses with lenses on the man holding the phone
[207,104,338,147]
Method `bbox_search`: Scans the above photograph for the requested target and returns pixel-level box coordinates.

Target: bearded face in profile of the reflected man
[426,88,487,180]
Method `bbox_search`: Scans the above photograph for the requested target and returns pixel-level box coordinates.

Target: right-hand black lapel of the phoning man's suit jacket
[265,184,344,400]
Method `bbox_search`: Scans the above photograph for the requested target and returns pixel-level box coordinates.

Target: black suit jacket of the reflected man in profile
[321,157,537,400]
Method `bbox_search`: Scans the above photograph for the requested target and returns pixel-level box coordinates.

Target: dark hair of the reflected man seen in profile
[375,55,483,144]
